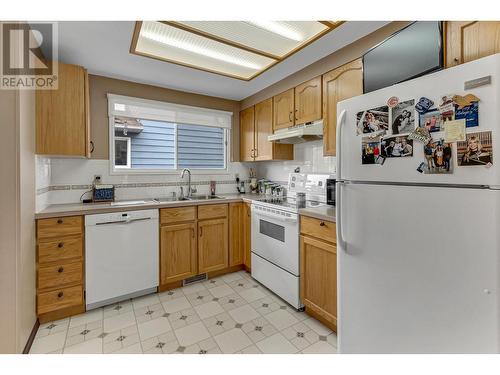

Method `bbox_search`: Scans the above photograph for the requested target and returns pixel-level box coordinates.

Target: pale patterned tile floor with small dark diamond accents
[30,271,337,354]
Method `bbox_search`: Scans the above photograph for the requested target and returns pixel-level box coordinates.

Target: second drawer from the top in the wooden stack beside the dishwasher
[38,236,83,264]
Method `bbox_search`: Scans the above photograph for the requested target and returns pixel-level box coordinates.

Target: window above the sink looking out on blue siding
[108,94,232,174]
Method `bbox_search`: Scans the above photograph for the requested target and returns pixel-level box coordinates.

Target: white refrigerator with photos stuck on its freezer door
[336,54,500,353]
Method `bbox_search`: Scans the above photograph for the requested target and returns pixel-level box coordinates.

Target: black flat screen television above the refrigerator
[363,21,443,93]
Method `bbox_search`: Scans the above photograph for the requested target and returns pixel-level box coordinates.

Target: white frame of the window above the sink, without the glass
[108,94,232,176]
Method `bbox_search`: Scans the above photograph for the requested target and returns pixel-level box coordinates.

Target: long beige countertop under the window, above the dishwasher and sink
[35,194,262,219]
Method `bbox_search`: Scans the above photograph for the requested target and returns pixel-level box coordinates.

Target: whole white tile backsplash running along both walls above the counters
[36,141,335,211]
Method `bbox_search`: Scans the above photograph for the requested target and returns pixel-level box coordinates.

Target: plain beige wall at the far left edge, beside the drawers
[0,22,36,354]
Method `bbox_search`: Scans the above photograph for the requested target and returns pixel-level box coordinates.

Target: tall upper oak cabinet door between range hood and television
[323,59,363,156]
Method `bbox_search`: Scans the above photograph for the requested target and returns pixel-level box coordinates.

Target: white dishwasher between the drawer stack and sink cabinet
[85,210,159,310]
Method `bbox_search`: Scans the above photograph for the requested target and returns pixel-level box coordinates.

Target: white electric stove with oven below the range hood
[252,173,332,309]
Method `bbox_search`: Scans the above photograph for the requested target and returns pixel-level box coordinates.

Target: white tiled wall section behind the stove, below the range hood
[255,140,336,184]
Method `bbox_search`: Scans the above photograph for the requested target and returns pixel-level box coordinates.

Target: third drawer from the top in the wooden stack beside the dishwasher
[38,262,83,289]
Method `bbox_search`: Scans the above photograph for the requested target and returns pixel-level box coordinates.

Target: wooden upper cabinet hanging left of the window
[36,63,90,157]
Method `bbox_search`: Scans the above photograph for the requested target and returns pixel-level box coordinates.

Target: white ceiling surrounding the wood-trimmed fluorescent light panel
[47,21,388,100]
